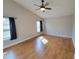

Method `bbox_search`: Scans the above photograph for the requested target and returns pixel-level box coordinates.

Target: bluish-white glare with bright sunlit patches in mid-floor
[35,36,48,56]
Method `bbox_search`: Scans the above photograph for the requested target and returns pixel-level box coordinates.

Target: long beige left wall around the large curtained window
[3,0,43,48]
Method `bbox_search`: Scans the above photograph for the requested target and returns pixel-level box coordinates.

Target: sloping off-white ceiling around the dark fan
[14,0,75,18]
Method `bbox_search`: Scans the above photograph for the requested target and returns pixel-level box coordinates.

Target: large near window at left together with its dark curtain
[3,17,17,40]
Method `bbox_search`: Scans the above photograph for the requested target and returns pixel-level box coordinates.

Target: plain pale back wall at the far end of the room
[45,15,73,38]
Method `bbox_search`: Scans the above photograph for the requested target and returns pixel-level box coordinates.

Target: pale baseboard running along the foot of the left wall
[3,32,43,50]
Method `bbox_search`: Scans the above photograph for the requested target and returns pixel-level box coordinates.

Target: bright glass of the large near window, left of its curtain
[3,17,10,40]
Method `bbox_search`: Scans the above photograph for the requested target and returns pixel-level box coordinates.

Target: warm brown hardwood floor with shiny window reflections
[4,35,74,59]
